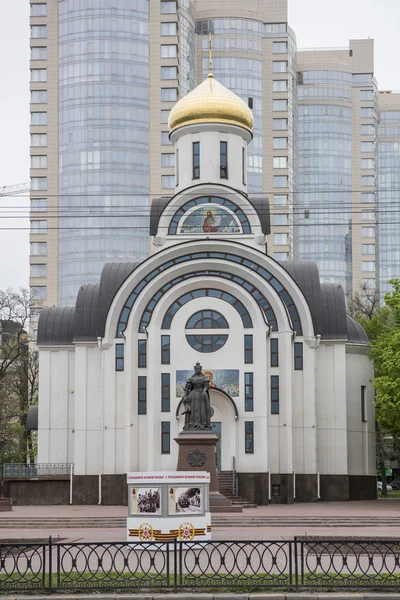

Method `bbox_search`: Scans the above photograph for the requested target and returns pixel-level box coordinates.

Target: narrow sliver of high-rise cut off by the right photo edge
[377,92,400,295]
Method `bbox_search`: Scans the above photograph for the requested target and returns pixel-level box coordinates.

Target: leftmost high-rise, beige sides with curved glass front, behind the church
[30,0,195,318]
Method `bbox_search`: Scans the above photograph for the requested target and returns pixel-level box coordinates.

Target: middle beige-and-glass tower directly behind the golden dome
[196,0,297,260]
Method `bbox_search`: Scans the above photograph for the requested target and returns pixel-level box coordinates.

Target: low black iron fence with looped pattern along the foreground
[0,538,400,593]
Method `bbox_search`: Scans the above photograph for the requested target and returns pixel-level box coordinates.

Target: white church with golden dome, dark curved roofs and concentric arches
[37,73,376,505]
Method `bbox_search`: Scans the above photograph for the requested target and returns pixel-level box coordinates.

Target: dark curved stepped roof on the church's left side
[37,262,138,346]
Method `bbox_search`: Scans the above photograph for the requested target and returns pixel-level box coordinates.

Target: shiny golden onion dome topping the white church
[168,73,254,133]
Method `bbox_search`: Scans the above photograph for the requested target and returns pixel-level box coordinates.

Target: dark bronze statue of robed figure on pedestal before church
[182,362,211,431]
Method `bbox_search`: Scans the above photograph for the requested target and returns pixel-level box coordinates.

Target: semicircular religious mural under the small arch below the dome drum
[178,204,242,233]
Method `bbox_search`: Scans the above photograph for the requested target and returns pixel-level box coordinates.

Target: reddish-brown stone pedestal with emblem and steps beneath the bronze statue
[174,431,243,513]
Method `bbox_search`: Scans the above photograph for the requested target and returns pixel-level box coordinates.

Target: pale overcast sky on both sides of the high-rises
[0,0,400,290]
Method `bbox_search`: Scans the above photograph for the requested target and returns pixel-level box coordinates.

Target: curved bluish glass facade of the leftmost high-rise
[58,0,149,305]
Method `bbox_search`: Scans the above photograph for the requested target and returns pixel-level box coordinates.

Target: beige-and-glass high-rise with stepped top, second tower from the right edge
[297,40,378,294]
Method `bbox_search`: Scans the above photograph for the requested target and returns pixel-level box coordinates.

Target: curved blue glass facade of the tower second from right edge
[298,88,352,293]
